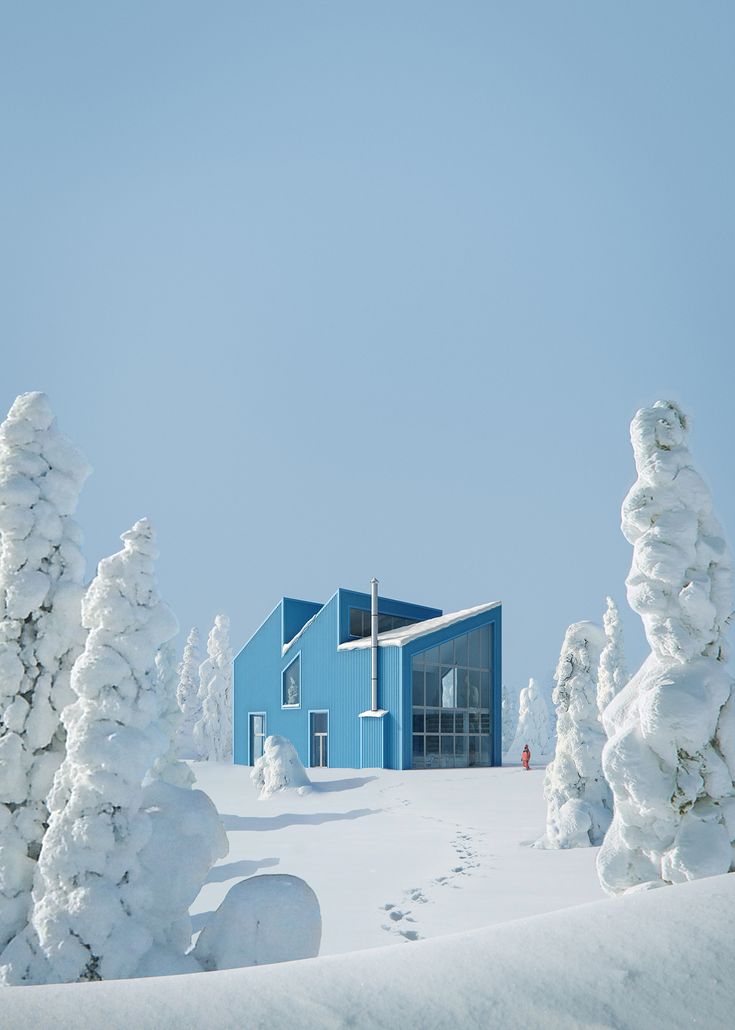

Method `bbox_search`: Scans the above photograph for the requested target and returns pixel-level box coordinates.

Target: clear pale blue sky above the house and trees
[0,0,735,700]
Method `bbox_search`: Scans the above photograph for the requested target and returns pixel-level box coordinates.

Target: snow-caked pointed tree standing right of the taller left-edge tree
[27,519,186,983]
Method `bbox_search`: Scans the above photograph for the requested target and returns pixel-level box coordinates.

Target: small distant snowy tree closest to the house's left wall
[194,615,233,762]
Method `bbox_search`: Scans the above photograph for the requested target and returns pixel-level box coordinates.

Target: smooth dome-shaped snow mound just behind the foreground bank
[194,873,321,970]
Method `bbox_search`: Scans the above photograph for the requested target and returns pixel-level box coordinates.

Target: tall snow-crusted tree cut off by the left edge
[0,393,91,951]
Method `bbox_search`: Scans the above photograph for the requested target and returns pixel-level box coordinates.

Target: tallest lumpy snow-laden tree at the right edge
[597,401,735,894]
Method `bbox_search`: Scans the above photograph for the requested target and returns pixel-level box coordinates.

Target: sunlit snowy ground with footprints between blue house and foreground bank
[184,762,603,955]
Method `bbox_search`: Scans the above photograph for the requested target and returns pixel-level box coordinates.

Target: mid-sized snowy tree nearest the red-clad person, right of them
[538,622,613,848]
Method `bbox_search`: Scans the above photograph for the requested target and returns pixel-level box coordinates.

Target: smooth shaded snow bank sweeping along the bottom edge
[0,877,735,1030]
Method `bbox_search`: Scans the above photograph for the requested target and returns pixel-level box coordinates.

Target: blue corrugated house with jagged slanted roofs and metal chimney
[235,581,501,769]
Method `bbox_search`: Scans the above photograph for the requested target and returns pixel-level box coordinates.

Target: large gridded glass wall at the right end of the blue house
[411,626,493,769]
